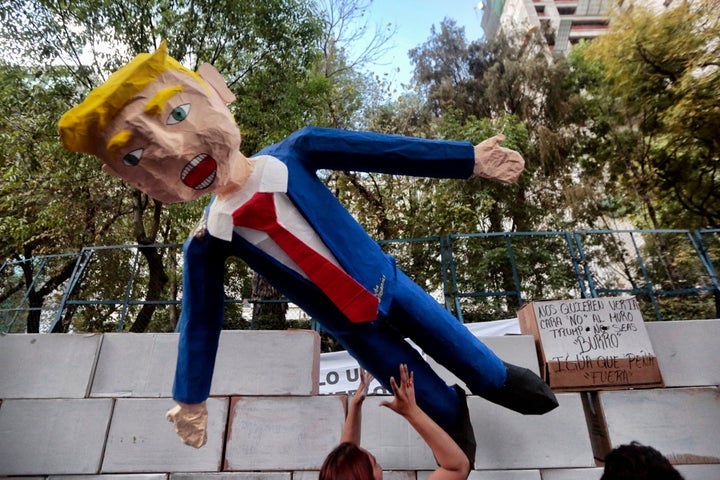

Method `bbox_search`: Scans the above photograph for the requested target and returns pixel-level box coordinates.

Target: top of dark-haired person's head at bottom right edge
[600,442,683,480]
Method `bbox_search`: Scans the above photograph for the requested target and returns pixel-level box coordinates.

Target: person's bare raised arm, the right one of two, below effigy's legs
[380,364,470,480]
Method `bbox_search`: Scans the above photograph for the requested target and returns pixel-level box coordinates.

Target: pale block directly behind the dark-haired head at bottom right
[597,387,720,464]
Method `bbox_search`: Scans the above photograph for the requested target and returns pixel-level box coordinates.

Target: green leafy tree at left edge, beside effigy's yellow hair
[0,65,130,333]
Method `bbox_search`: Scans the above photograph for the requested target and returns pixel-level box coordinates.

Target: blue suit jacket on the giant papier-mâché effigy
[173,127,475,403]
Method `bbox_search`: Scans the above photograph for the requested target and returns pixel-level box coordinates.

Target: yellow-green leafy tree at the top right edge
[586,0,720,228]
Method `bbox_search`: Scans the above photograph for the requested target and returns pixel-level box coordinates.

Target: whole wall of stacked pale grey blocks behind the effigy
[0,320,720,480]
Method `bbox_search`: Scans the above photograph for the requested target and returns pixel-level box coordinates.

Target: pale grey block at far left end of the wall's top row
[0,334,102,399]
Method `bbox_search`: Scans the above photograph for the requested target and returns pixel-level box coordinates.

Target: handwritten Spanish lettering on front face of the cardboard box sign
[533,297,657,385]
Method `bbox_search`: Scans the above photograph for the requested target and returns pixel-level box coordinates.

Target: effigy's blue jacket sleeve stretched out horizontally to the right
[261,127,475,179]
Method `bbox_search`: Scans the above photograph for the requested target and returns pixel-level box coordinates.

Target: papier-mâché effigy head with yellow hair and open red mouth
[58,42,240,203]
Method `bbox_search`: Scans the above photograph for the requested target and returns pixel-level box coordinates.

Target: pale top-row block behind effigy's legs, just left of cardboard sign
[427,335,540,393]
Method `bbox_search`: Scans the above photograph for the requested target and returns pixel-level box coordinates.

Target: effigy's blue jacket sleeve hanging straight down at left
[173,231,227,404]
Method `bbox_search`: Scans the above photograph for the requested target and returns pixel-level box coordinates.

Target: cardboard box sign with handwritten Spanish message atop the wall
[518,297,662,390]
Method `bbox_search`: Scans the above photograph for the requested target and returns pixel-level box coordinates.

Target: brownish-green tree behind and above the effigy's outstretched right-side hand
[410,19,600,231]
